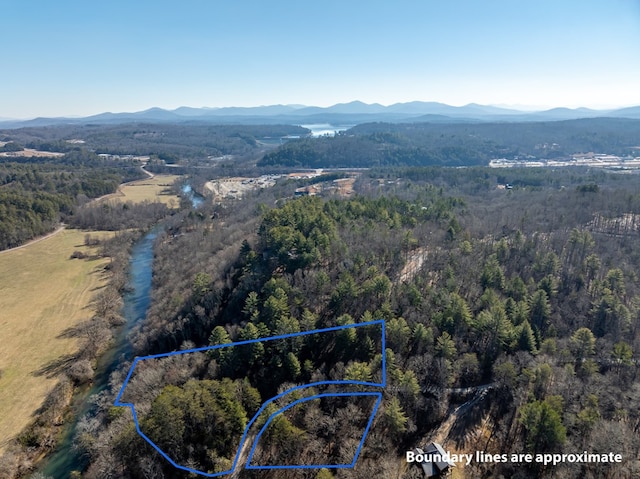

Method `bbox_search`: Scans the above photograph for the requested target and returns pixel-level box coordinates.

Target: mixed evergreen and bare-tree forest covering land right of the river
[1,168,640,479]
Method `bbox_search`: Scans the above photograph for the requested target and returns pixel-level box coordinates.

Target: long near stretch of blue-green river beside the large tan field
[41,230,160,479]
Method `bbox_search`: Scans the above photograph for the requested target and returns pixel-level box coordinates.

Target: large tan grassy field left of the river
[0,230,112,453]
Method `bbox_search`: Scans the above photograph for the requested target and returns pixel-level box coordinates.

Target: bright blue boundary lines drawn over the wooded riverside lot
[114,319,387,477]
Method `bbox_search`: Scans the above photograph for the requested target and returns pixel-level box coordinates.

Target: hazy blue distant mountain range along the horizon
[0,101,640,128]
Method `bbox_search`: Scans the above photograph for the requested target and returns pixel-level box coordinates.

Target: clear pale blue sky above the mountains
[0,0,640,118]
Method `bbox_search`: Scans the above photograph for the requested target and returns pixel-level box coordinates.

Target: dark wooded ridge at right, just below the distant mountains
[258,118,640,168]
